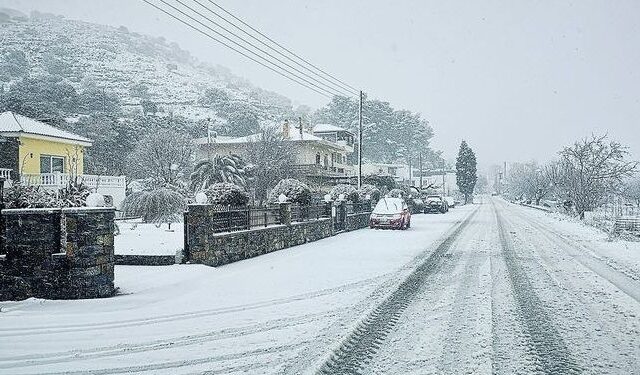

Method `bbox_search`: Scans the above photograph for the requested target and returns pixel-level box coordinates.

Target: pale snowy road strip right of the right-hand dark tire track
[492,203,640,374]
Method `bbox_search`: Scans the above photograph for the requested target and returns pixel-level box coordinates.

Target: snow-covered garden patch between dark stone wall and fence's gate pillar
[114,219,184,255]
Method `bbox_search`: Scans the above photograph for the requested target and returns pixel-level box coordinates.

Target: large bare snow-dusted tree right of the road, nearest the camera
[556,135,638,219]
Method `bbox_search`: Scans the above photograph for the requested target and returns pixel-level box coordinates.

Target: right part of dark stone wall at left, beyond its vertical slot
[62,207,115,298]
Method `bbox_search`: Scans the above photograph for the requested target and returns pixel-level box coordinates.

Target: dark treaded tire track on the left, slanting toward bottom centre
[318,208,478,374]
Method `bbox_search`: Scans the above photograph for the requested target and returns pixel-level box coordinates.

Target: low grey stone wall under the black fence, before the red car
[189,218,333,267]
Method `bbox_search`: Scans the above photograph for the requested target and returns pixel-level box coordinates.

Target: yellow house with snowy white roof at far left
[0,111,91,177]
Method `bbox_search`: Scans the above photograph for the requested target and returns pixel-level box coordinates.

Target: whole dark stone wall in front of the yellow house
[0,208,115,300]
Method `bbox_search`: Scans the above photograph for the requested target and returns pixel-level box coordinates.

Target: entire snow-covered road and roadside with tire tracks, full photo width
[0,203,640,374]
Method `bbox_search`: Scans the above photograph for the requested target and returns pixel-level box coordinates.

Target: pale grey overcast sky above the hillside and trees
[0,0,640,165]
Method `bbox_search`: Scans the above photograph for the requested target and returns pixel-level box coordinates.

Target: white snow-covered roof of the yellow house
[0,111,92,146]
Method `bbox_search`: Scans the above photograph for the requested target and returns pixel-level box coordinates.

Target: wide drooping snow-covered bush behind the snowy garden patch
[122,187,185,223]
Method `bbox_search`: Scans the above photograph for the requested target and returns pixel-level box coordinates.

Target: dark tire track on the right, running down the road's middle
[491,199,582,374]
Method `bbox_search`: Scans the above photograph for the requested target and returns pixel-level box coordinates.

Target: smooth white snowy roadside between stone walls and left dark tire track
[0,206,475,374]
